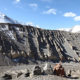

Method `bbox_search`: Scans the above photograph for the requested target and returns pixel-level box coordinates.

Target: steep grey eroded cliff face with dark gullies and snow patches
[0,24,80,64]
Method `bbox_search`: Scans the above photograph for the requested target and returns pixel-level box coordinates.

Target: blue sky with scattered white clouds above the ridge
[0,0,80,30]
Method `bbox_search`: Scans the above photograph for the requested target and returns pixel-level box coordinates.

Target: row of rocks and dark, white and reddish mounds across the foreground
[2,63,80,80]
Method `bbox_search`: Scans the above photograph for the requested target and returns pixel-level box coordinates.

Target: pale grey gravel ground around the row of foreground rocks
[0,63,80,80]
